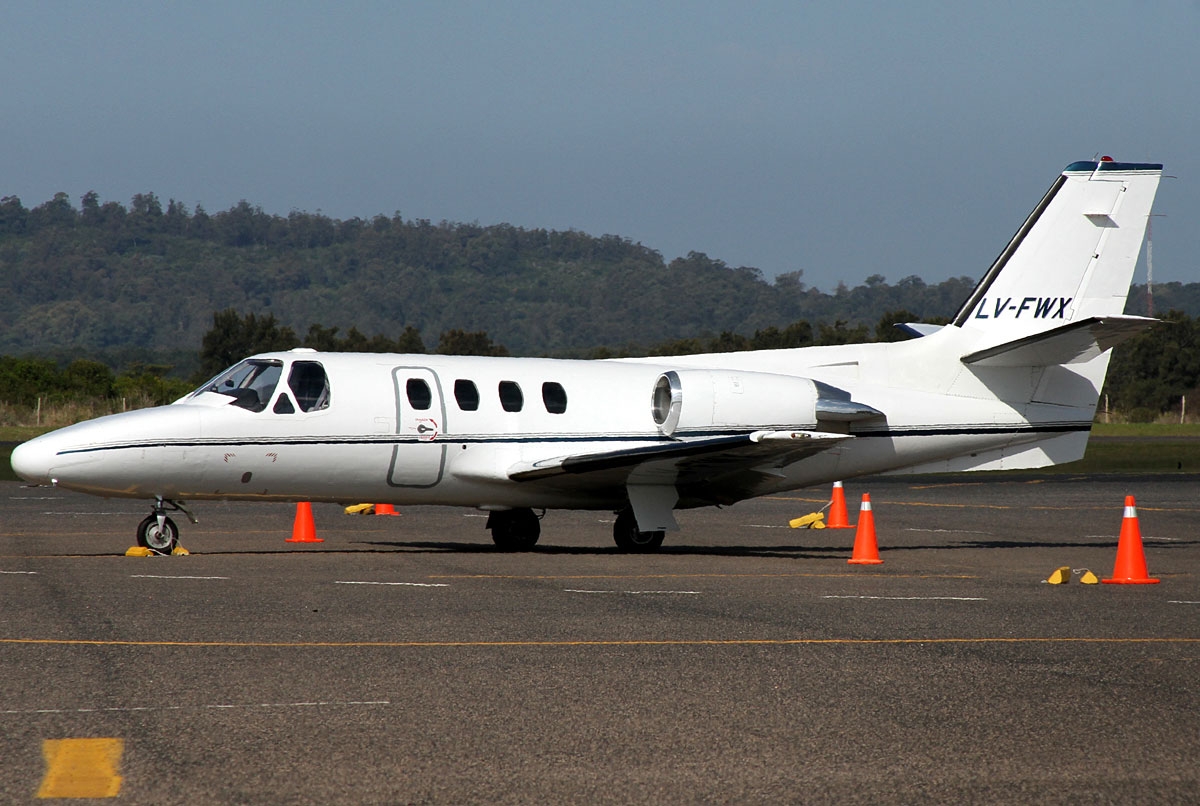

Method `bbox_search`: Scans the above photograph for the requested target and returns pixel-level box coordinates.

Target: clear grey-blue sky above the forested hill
[0,0,1200,291]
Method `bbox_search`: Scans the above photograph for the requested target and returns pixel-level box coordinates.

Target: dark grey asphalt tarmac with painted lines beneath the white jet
[0,475,1200,804]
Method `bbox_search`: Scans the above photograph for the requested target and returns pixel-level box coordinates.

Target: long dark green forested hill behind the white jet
[0,193,1200,369]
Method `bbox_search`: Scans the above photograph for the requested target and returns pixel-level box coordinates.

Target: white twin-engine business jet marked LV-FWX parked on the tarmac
[12,157,1163,553]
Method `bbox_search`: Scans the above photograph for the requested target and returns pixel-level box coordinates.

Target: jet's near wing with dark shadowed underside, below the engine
[508,431,853,504]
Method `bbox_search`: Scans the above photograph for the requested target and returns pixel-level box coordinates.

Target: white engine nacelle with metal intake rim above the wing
[650,369,821,437]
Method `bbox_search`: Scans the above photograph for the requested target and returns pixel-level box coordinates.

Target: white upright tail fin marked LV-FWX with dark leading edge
[954,157,1163,338]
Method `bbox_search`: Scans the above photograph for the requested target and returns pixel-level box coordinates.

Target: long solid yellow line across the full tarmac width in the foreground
[0,636,1200,649]
